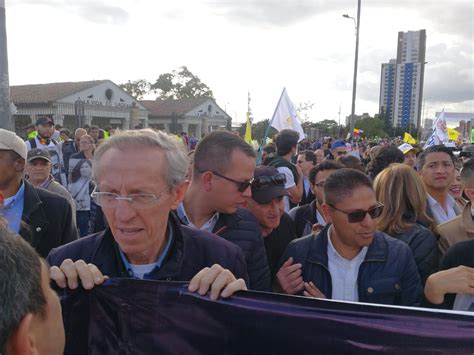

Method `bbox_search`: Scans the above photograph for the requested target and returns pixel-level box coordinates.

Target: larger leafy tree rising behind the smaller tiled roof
[151,66,214,100]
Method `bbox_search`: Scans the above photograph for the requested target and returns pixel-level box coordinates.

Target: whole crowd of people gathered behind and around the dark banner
[0,117,474,354]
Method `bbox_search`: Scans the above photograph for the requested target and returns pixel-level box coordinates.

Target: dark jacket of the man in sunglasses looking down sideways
[213,208,272,291]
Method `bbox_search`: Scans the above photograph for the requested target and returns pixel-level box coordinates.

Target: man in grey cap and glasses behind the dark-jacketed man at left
[25,148,76,223]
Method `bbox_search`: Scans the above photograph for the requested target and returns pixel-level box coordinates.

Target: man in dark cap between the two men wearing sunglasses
[247,165,295,279]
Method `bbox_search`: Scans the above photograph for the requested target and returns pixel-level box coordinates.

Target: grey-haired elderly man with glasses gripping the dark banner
[48,130,247,299]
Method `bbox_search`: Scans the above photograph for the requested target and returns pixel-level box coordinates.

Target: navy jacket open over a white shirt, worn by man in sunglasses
[280,226,422,306]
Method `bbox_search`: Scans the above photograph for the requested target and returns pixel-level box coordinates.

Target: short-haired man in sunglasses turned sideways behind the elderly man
[176,131,271,291]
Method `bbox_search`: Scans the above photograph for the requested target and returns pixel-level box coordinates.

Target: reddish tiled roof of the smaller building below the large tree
[139,97,212,117]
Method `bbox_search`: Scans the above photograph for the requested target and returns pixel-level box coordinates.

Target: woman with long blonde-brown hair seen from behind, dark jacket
[374,164,439,285]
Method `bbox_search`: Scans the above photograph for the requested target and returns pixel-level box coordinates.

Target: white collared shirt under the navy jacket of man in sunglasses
[328,226,368,302]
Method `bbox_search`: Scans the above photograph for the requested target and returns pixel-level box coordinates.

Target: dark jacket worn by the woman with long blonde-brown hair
[386,223,439,287]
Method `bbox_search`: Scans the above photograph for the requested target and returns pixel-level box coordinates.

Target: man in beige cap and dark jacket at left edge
[0,129,78,257]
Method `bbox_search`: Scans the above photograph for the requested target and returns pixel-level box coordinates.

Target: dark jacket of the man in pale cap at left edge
[19,180,78,258]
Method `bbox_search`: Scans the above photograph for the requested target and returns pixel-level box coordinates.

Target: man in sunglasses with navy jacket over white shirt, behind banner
[277,168,421,306]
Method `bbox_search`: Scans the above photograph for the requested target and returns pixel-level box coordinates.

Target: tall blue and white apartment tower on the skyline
[379,30,426,128]
